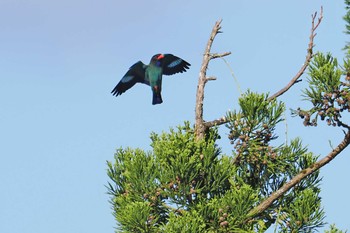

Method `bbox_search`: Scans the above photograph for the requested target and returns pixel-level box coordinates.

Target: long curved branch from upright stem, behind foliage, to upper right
[204,7,323,128]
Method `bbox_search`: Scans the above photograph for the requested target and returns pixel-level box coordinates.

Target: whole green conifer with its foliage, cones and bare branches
[107,0,350,233]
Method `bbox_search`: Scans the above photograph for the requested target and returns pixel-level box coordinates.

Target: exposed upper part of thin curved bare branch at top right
[269,7,323,100]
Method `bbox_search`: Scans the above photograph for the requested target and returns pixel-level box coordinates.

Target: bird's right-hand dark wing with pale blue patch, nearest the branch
[162,54,191,75]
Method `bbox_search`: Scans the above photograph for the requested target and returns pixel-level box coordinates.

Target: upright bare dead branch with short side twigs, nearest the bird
[195,20,231,140]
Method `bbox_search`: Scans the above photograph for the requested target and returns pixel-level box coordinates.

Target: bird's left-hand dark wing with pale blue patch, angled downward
[111,61,149,96]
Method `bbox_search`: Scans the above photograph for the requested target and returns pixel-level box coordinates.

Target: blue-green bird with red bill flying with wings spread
[111,54,190,105]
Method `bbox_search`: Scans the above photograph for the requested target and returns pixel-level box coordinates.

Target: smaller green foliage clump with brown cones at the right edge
[293,53,350,127]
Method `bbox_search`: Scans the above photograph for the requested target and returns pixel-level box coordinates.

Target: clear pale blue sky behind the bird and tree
[0,0,350,233]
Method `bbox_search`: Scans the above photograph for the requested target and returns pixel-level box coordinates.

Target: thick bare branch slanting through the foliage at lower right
[246,131,350,222]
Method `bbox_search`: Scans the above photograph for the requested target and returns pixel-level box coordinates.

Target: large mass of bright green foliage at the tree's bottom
[108,95,324,232]
